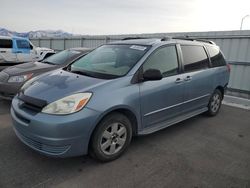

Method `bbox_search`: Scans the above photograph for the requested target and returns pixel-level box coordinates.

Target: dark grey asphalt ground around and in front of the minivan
[0,100,250,188]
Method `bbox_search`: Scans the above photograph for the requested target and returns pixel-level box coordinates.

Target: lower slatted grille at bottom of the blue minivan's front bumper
[16,131,70,155]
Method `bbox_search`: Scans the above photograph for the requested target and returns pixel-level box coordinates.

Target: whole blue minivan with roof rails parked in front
[11,38,230,161]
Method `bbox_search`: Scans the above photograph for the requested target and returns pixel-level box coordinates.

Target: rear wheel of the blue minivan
[207,89,222,116]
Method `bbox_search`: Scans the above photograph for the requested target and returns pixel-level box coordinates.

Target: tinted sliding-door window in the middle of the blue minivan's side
[181,45,209,72]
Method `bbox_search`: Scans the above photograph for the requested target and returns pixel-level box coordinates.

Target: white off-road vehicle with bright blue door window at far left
[0,36,55,65]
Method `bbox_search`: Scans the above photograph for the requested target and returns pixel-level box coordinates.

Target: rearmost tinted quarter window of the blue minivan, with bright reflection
[207,46,226,67]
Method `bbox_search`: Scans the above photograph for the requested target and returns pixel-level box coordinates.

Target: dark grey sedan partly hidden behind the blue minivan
[0,48,90,100]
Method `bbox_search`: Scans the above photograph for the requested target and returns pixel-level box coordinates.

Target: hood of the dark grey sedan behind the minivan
[4,62,57,76]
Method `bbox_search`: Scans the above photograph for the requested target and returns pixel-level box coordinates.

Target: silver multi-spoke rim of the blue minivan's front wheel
[100,123,127,155]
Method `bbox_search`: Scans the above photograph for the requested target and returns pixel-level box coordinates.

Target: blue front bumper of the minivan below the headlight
[11,97,100,157]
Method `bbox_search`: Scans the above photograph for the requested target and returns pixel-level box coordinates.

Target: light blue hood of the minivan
[23,70,112,103]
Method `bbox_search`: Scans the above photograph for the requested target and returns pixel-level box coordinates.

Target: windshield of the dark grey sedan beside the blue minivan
[42,50,81,65]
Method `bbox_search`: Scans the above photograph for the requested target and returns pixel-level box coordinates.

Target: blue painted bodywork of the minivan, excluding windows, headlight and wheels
[11,41,229,157]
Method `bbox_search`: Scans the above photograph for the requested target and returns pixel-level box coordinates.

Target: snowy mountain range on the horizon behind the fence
[0,28,74,38]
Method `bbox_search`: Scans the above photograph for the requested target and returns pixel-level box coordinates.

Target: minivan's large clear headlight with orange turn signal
[42,93,92,114]
